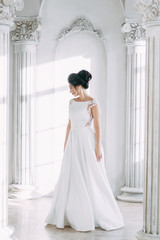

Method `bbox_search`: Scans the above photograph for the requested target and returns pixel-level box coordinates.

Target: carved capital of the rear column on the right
[121,23,146,43]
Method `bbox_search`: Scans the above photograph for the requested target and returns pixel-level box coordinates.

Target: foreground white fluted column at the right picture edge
[136,0,160,240]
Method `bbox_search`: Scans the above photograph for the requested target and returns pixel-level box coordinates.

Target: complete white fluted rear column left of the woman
[9,18,40,199]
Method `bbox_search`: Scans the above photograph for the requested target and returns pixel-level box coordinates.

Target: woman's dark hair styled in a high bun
[68,70,92,89]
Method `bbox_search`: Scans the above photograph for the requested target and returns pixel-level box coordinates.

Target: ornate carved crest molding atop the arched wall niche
[58,17,105,40]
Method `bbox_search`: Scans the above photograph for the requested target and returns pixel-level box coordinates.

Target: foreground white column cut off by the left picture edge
[0,0,23,240]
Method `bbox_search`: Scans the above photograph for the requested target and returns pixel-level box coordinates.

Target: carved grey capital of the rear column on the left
[11,17,40,44]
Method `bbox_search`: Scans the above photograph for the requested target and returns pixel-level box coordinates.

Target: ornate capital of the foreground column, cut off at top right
[135,0,160,21]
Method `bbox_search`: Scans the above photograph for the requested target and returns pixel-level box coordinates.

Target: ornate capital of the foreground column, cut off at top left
[0,0,24,25]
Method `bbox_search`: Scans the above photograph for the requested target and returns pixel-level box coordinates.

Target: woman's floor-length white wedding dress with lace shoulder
[45,99,124,231]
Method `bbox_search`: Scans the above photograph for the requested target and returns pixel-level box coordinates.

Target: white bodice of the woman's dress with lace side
[69,99,97,128]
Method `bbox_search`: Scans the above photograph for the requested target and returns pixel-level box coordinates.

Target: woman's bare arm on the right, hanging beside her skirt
[91,104,102,161]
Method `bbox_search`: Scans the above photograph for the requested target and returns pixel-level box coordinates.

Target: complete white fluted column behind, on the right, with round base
[117,23,145,202]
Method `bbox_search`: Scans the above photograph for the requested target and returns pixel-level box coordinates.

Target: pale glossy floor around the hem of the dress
[9,198,143,240]
